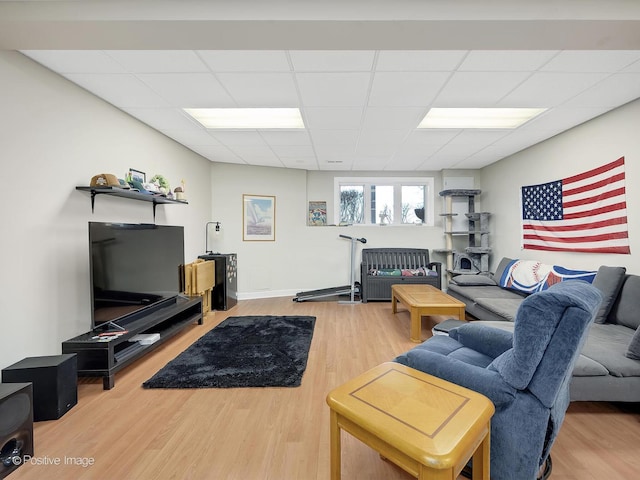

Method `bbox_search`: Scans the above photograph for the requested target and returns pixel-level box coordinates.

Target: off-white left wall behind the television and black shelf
[0,51,211,368]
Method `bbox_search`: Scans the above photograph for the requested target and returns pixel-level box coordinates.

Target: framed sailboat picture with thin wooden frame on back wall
[242,194,276,242]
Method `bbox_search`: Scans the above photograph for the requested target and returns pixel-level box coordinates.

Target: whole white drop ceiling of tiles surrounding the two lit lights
[18,45,640,171]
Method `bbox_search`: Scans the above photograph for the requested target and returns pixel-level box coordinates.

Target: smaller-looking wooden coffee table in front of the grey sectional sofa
[391,284,465,343]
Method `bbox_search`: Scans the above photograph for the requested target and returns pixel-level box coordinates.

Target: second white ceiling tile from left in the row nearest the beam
[105,50,209,73]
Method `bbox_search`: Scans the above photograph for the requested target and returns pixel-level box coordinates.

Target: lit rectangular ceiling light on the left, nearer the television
[184,108,304,129]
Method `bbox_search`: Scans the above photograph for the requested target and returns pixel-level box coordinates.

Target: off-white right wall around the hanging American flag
[482,100,640,274]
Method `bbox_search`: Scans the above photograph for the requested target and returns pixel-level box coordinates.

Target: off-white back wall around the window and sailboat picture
[210,167,452,298]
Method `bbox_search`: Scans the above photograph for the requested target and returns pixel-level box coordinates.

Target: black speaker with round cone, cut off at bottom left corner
[0,383,33,478]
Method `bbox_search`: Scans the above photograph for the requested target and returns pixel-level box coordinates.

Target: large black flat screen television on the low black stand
[89,222,184,329]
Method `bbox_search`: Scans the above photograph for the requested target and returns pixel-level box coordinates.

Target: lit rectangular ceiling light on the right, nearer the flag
[418,108,546,128]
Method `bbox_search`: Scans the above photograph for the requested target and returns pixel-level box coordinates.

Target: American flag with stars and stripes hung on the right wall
[521,157,631,253]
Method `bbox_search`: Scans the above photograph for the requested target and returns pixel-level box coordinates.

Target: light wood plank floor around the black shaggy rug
[9,298,640,480]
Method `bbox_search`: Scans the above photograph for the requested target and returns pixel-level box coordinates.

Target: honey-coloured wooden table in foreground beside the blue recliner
[327,363,494,480]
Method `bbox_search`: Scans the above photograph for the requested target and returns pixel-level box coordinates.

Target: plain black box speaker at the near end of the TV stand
[2,353,78,422]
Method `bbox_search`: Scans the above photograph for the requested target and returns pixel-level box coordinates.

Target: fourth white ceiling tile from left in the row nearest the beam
[289,50,375,72]
